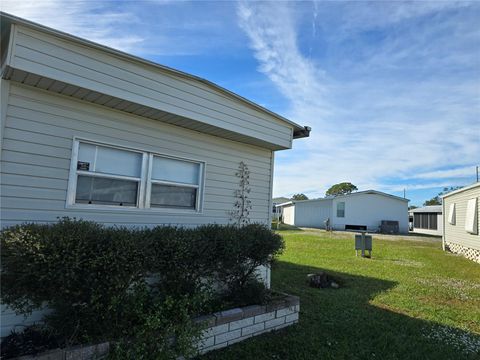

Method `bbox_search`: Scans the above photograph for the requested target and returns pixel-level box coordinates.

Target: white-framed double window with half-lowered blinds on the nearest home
[68,141,205,211]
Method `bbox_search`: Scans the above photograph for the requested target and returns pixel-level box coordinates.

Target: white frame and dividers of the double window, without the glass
[65,137,206,211]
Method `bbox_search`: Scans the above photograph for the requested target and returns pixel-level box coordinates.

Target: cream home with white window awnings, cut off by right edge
[443,182,480,263]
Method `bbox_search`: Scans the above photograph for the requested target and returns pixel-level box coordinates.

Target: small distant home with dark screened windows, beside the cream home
[408,205,443,236]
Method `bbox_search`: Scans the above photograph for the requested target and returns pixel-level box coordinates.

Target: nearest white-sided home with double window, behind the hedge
[0,13,310,336]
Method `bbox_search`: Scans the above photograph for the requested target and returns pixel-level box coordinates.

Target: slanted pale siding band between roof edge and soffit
[12,28,292,147]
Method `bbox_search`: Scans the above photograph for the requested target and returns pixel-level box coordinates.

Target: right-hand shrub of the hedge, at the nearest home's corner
[144,224,284,306]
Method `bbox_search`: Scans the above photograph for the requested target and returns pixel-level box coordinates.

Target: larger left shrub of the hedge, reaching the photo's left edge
[1,219,145,342]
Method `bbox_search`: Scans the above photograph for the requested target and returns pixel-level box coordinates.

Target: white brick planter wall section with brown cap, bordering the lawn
[195,294,300,354]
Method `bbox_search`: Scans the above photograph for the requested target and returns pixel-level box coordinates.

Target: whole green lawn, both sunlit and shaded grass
[203,230,480,360]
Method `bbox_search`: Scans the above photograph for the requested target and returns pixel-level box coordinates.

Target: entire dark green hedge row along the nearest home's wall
[0,218,284,358]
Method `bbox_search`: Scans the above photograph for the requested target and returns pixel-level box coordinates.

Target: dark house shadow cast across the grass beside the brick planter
[202,261,480,360]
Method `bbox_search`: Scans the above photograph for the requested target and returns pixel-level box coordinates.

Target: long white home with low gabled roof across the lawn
[278,190,408,233]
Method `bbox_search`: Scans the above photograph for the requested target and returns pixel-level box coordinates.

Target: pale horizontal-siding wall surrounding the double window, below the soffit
[1,83,271,226]
